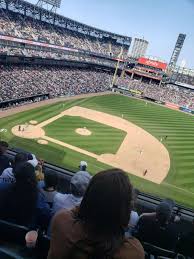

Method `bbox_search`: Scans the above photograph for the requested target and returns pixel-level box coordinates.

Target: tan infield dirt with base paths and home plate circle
[12,106,170,184]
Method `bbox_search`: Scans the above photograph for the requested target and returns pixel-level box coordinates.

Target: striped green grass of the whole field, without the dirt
[0,95,194,208]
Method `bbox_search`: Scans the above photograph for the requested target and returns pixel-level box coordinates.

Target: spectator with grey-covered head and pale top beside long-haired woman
[53,171,91,213]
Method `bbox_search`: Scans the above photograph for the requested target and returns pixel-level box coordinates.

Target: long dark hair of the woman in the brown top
[78,169,133,238]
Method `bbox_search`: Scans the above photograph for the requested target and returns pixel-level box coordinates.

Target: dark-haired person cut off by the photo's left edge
[0,141,11,175]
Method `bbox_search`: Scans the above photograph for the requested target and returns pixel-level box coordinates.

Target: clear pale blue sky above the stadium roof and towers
[28,0,194,69]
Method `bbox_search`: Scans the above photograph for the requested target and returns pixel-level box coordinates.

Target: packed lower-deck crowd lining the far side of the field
[0,65,194,109]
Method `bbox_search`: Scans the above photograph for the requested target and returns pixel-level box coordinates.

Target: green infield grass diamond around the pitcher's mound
[44,116,126,155]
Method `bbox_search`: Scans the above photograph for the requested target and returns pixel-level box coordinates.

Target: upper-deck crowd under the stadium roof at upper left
[0,10,129,56]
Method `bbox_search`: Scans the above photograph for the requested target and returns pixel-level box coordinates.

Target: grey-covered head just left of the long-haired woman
[70,171,92,197]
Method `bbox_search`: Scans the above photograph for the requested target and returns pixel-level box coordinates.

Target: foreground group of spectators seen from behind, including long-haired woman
[0,141,194,259]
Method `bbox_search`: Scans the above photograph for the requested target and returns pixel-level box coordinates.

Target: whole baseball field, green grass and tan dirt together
[0,94,194,208]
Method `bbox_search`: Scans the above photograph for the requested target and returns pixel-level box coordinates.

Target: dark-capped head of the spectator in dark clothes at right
[156,201,173,225]
